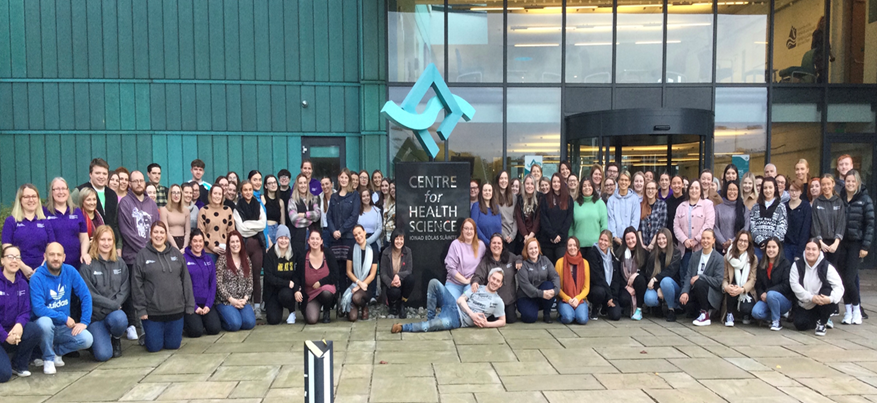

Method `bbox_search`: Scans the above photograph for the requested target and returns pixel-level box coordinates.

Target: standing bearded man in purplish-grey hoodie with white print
[119,171,161,340]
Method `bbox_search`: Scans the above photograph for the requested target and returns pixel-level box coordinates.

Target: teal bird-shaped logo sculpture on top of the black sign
[381,63,475,158]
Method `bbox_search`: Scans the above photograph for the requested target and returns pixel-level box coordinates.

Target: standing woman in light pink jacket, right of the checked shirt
[673,181,716,280]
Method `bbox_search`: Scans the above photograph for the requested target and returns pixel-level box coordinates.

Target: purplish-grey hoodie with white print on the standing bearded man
[119,192,161,264]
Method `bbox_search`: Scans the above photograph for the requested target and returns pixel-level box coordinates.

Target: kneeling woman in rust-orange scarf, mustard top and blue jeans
[554,236,591,325]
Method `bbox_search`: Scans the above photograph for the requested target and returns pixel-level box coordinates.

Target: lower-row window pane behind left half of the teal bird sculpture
[389,87,445,163]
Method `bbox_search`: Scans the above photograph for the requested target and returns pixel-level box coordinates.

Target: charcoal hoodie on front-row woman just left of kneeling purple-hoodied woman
[131,242,195,318]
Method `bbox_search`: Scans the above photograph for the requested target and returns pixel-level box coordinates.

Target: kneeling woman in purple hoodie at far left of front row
[0,245,42,383]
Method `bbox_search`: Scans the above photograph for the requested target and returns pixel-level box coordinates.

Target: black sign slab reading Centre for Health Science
[394,162,470,306]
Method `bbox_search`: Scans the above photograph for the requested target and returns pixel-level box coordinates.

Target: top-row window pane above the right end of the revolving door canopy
[667,1,713,83]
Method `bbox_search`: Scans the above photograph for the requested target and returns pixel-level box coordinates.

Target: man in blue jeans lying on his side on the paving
[391,267,505,333]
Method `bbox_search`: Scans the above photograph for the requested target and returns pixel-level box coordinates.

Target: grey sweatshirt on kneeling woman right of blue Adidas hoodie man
[79,257,131,323]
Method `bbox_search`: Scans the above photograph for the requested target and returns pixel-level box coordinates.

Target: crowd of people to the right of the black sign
[391,155,874,335]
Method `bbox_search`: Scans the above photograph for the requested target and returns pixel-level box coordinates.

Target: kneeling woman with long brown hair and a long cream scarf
[722,230,758,327]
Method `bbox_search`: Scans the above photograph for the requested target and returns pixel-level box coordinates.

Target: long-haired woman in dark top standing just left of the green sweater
[539,173,573,265]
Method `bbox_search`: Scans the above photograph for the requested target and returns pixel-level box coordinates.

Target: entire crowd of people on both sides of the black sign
[0,156,874,381]
